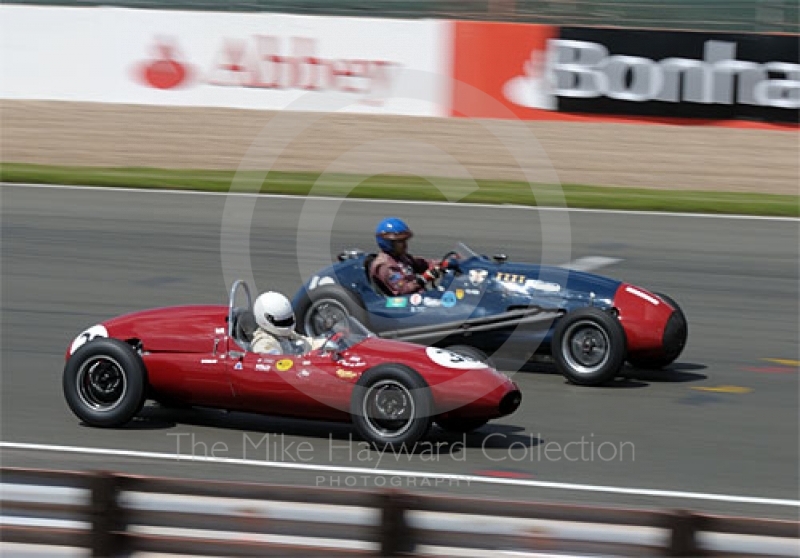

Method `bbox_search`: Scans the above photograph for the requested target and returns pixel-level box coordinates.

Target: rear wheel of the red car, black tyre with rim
[62,338,147,427]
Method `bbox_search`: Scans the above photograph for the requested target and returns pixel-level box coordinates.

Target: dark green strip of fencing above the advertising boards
[7,0,800,33]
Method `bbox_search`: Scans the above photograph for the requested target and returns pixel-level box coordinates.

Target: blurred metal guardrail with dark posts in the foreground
[0,468,800,556]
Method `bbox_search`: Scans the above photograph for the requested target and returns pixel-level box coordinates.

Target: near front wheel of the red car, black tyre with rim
[350,364,433,450]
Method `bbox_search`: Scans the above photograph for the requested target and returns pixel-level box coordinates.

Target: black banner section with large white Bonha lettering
[546,27,800,123]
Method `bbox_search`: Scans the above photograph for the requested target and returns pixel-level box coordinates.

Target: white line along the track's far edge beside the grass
[0,182,800,223]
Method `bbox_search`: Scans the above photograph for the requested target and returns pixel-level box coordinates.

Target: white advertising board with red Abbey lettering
[0,5,450,116]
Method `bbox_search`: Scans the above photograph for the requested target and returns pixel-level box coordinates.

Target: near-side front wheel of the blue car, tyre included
[551,308,627,386]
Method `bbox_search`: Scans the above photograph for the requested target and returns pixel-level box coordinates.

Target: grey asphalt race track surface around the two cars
[0,186,800,519]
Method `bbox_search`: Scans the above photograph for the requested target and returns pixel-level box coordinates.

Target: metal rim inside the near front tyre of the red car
[361,380,416,438]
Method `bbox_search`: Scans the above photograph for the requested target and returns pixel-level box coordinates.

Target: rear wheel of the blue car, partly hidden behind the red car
[295,285,369,337]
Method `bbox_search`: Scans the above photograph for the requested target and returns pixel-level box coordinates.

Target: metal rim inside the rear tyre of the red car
[75,356,128,413]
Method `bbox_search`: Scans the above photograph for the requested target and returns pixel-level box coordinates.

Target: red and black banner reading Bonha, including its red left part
[452,22,800,123]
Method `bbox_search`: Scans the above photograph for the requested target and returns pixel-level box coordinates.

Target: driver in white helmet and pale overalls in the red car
[250,291,324,355]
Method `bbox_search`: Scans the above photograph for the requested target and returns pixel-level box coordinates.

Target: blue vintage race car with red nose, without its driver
[292,243,688,385]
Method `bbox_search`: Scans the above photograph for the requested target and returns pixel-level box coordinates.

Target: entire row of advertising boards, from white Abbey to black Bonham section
[0,4,800,128]
